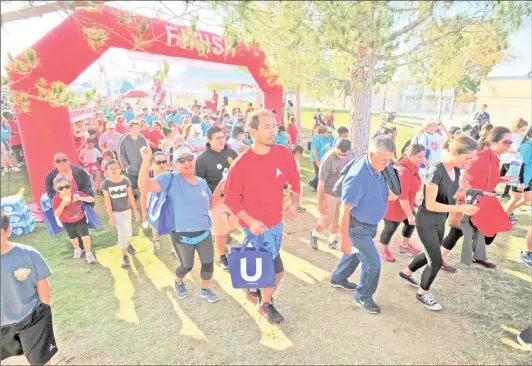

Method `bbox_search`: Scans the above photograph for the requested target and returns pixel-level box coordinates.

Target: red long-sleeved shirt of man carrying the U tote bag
[224,145,301,228]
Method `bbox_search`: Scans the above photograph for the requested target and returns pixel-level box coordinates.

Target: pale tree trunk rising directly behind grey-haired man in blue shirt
[349,49,375,155]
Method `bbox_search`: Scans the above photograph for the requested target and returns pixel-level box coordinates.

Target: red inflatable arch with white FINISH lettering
[9,6,283,202]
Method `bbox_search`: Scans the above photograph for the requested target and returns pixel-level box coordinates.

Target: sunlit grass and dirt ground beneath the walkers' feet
[1,112,532,365]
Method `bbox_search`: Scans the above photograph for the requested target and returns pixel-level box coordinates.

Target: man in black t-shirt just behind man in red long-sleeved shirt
[196,126,238,269]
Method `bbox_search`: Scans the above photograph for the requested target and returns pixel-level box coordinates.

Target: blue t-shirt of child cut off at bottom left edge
[0,244,52,326]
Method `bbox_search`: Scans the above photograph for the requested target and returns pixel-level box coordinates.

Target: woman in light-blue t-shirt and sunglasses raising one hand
[139,147,225,303]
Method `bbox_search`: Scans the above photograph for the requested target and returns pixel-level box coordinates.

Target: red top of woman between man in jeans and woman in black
[384,158,421,222]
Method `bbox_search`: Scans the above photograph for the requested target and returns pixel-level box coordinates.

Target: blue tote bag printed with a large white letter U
[227,235,275,288]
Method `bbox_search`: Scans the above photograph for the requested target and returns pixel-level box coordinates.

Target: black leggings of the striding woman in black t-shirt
[408,221,445,291]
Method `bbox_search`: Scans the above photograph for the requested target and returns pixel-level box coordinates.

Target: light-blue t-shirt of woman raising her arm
[154,172,212,233]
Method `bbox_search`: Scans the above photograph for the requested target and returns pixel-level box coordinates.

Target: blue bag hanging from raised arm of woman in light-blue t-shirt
[147,173,175,235]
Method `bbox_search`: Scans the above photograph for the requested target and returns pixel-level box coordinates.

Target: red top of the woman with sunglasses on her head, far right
[465,147,501,192]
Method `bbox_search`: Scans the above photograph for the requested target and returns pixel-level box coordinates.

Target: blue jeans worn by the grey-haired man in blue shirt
[332,224,381,300]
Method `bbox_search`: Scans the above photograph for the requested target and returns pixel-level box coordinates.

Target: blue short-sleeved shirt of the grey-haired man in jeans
[342,155,388,225]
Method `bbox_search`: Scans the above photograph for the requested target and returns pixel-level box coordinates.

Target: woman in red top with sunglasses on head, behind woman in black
[441,126,512,273]
